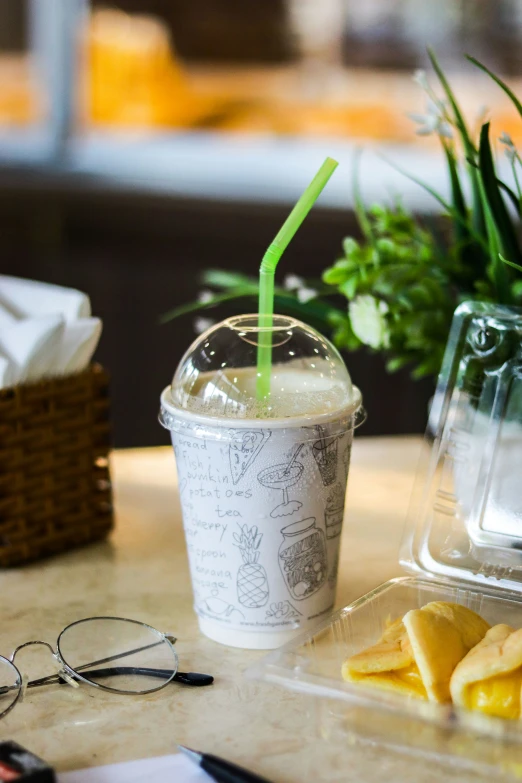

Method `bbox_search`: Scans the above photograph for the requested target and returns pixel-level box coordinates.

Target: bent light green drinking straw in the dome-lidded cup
[256,158,339,400]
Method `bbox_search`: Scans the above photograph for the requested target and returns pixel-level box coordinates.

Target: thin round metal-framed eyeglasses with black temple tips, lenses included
[0,617,214,718]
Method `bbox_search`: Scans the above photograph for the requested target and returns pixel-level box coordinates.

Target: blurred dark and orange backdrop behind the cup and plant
[0,0,522,446]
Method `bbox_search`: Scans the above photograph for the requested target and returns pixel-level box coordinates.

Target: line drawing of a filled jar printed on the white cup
[279,517,328,601]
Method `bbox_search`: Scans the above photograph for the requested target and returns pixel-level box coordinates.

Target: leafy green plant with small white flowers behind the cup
[163,50,522,377]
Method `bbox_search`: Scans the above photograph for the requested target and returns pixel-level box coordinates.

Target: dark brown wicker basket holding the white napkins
[0,365,113,567]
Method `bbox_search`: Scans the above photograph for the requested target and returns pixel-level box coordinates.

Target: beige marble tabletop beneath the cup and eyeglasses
[0,437,488,783]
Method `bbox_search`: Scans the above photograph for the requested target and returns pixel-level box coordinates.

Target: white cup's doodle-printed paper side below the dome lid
[173,416,351,631]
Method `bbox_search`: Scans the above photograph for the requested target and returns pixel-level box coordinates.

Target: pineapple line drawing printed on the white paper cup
[234,525,269,609]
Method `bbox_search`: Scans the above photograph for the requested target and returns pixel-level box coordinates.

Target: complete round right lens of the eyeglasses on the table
[58,617,177,693]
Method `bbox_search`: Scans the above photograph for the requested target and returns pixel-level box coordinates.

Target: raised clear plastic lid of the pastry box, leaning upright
[401,302,522,592]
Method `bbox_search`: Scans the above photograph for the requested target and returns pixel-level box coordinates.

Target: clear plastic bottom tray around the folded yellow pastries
[247,577,522,777]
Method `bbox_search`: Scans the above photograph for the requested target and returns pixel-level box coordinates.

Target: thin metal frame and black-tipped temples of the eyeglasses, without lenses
[0,616,214,719]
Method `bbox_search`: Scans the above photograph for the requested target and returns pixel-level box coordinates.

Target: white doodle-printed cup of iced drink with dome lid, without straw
[160,315,363,649]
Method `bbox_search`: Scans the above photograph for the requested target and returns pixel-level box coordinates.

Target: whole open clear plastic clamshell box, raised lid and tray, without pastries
[249,303,522,777]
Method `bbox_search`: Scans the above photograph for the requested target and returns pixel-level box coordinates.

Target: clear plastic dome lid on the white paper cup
[160,315,364,438]
